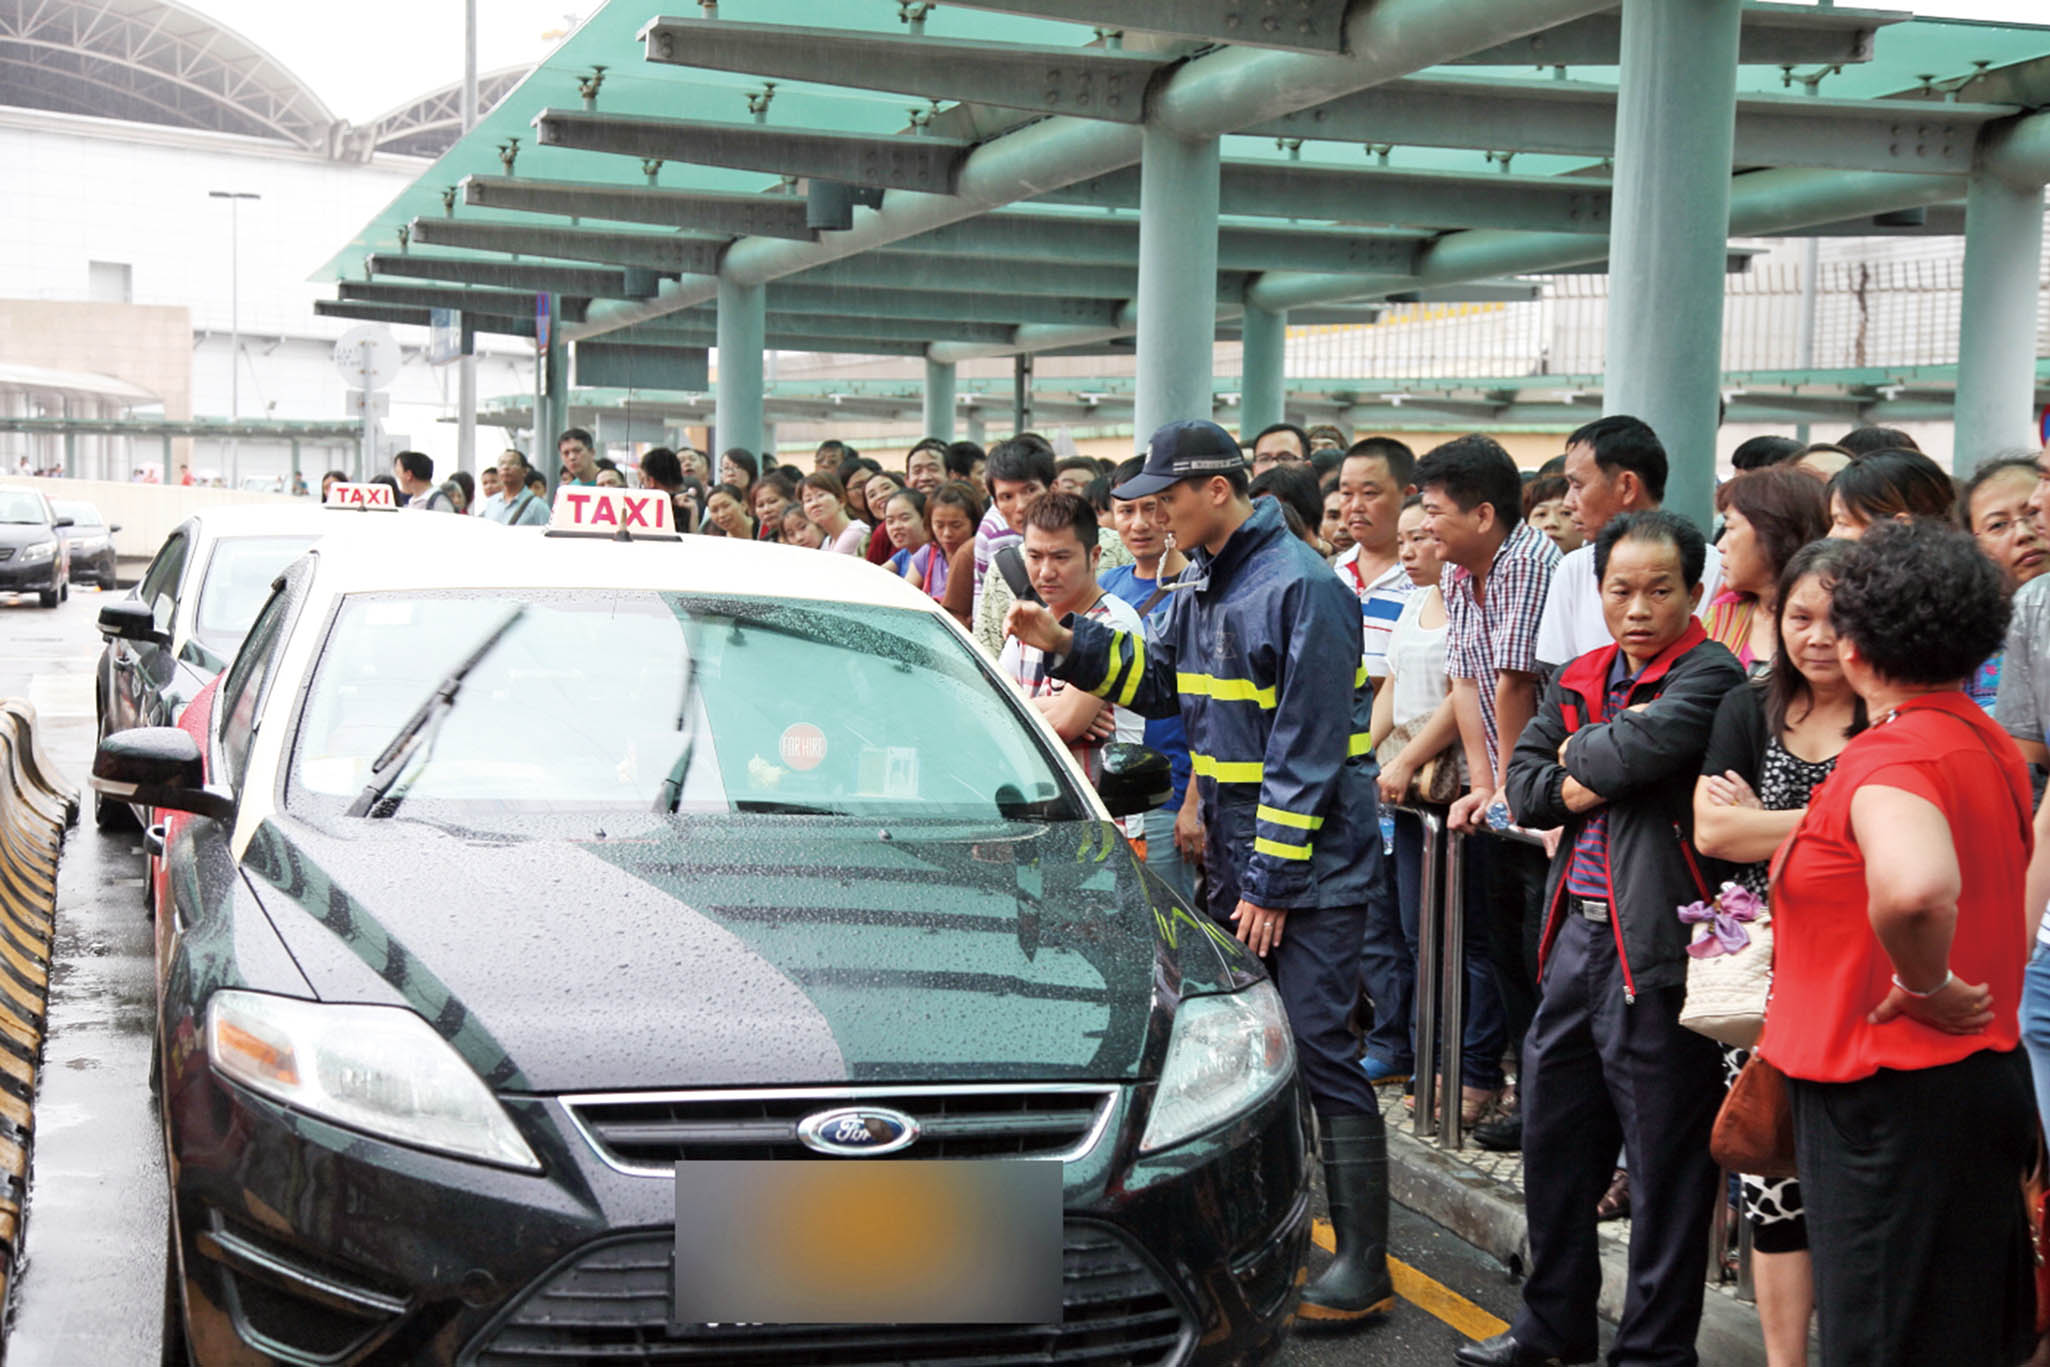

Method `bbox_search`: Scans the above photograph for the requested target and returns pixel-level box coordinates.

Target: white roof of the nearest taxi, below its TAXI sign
[301,512,941,613]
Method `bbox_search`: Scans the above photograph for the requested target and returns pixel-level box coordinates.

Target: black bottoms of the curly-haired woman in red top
[1795,1049,2036,1367]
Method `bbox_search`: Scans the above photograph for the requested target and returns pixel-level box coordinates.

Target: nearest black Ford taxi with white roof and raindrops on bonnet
[94,519,1310,1367]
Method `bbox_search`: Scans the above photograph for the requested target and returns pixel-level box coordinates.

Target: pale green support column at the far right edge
[1950,170,2044,475]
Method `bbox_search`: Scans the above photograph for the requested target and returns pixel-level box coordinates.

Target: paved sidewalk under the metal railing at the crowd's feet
[1380,1086,1765,1367]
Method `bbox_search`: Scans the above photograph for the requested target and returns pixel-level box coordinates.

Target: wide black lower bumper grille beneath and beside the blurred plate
[463,1224,1191,1367]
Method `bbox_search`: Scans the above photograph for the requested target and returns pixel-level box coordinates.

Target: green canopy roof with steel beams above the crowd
[316,0,2050,361]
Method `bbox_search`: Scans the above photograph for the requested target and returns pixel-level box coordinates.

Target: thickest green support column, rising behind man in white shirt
[1603,0,1743,527]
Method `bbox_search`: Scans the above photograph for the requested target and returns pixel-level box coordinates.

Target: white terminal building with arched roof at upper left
[0,0,533,488]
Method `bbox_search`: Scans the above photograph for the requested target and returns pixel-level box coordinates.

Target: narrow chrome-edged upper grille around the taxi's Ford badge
[562,1084,1117,1174]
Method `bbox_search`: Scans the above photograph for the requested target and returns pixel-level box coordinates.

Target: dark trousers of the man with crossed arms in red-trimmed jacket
[1513,914,1722,1367]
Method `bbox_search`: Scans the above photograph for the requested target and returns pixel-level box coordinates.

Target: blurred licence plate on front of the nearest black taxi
[670,1158,1062,1336]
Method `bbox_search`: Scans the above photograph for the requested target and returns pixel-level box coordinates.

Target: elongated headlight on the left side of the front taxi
[207,990,541,1172]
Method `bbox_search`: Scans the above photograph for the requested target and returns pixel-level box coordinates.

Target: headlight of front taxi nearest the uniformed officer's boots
[1140,982,1296,1150]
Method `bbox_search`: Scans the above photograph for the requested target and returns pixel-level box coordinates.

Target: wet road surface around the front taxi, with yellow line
[0,588,1566,1367]
